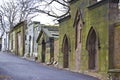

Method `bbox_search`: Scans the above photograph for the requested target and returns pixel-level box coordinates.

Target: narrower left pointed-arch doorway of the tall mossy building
[63,35,69,68]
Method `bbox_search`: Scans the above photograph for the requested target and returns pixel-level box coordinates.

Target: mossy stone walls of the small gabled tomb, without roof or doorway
[37,26,59,64]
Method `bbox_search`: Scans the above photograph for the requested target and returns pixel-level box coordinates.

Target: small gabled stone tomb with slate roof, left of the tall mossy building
[37,26,59,65]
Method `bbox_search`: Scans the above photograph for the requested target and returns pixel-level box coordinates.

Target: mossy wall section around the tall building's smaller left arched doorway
[58,1,80,70]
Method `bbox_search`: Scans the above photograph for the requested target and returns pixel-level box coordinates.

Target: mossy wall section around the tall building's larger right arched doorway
[81,0,109,72]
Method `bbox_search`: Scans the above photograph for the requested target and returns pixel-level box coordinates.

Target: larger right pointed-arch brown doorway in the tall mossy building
[86,28,97,70]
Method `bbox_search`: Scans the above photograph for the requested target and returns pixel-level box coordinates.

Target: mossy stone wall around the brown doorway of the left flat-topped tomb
[10,22,25,56]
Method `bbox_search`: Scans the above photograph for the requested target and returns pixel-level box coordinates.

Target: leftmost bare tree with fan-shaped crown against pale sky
[1,1,17,28]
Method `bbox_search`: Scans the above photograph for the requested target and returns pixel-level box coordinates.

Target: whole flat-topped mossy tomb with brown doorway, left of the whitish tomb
[9,22,26,56]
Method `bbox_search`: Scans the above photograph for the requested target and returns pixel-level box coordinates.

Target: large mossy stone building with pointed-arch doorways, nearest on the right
[59,0,120,80]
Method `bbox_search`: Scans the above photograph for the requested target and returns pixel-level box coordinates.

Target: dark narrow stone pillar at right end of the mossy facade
[108,0,119,69]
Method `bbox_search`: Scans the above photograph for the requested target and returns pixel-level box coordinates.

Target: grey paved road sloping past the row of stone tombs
[0,52,98,80]
